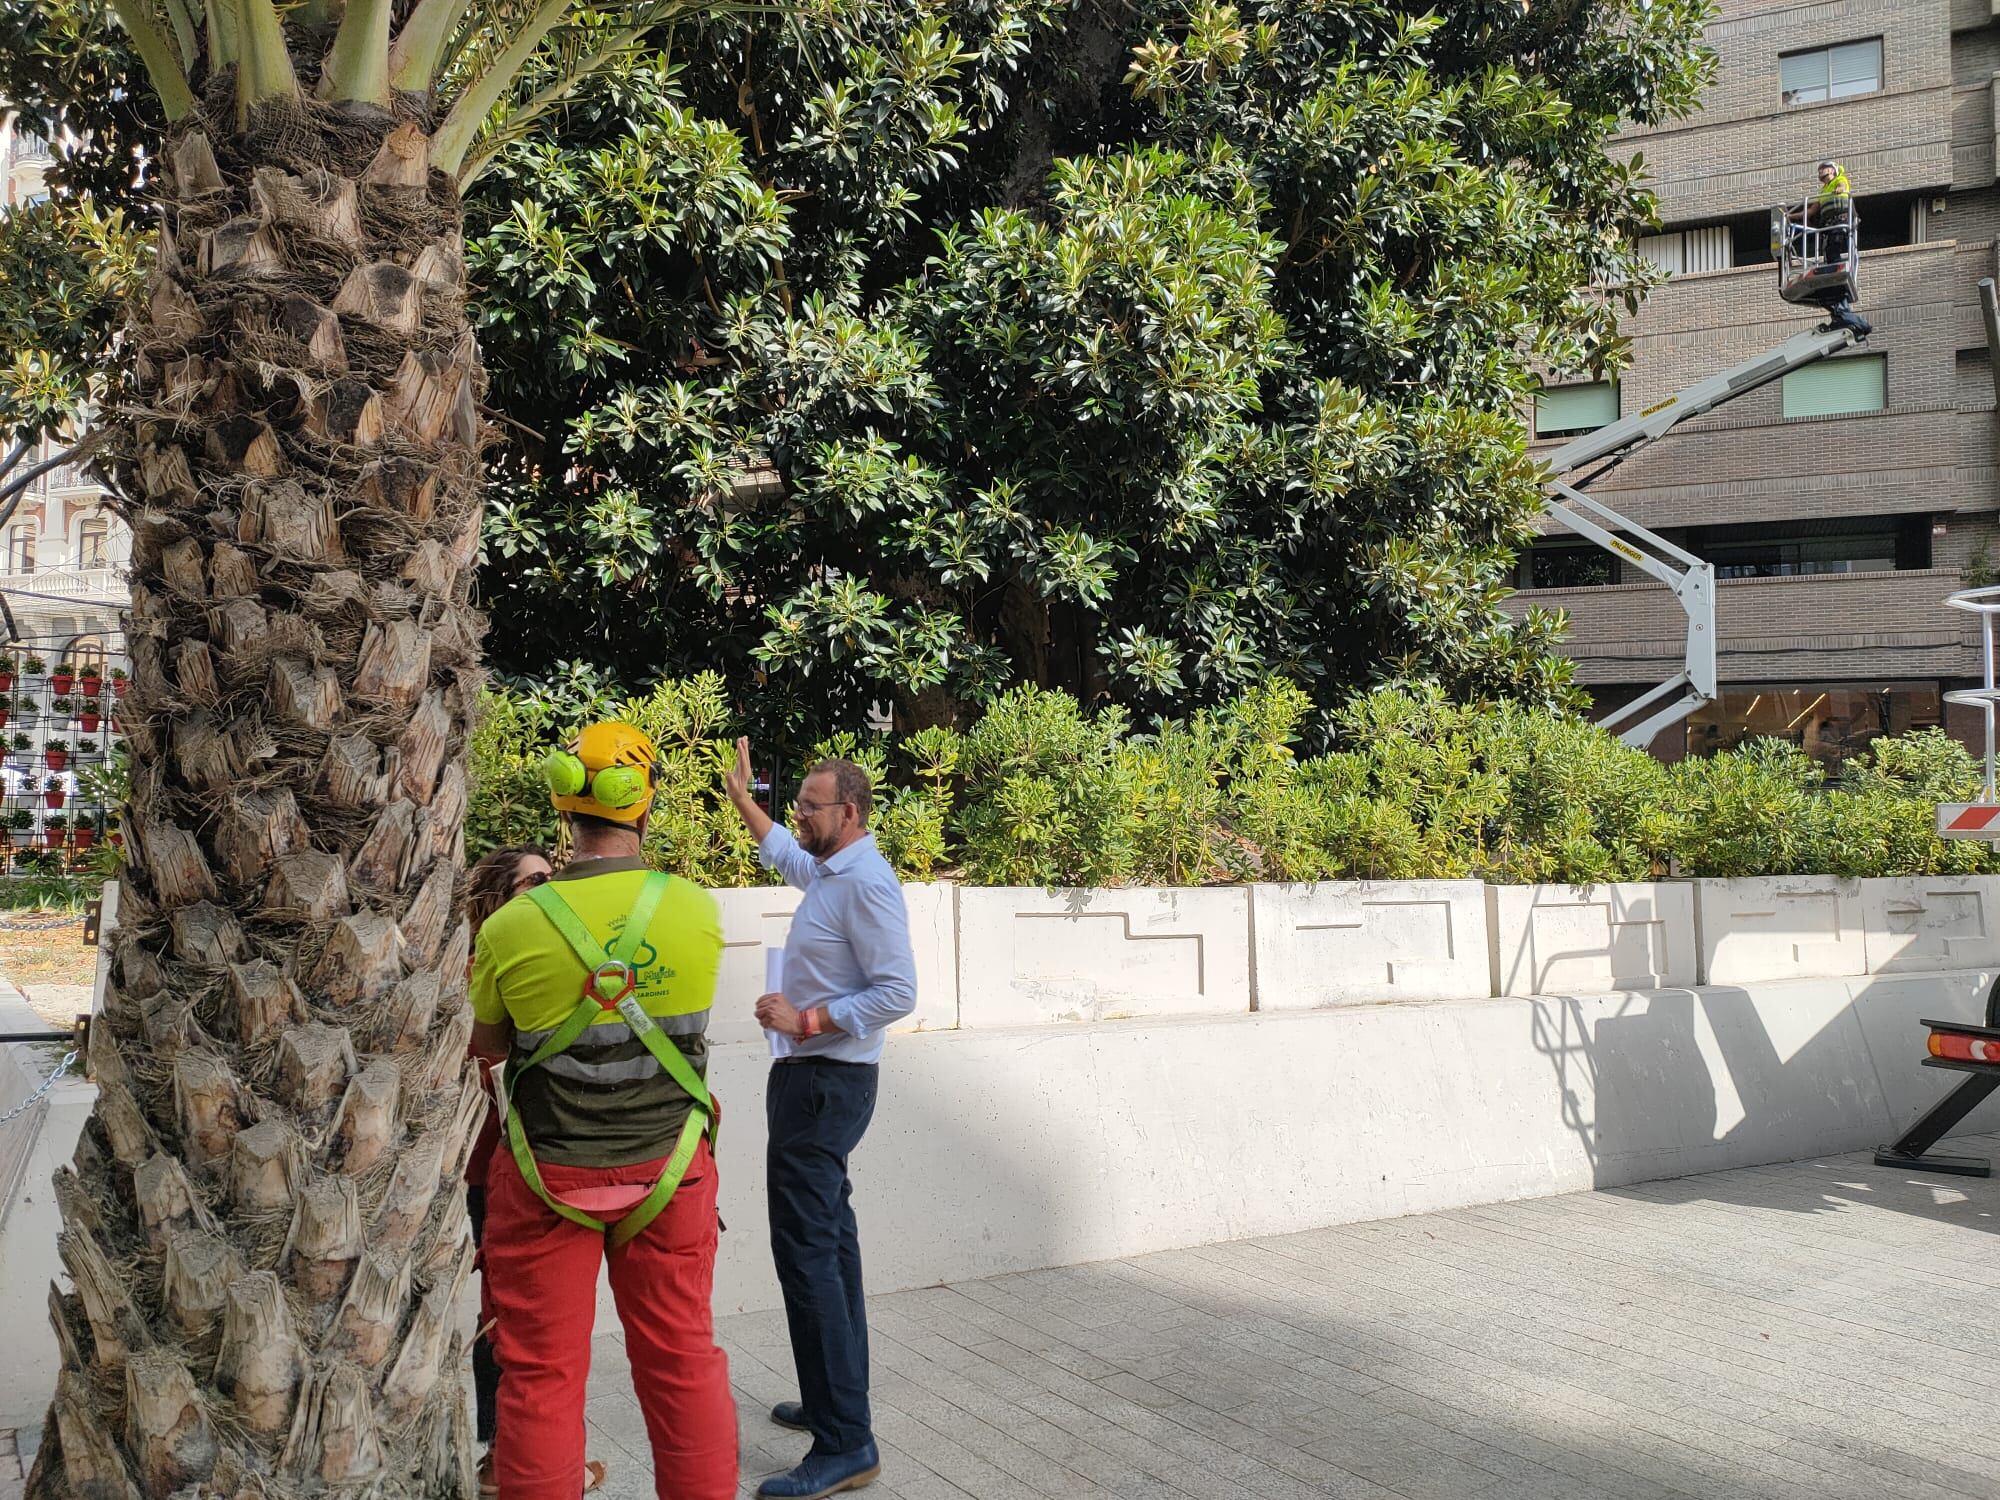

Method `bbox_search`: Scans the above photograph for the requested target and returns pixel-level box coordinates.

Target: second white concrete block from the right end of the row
[1694,876,1868,984]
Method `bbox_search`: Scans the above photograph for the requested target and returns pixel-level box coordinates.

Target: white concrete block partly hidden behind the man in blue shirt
[708,884,958,1044]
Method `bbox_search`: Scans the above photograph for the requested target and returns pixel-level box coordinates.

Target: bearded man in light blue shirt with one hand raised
[728,740,916,1500]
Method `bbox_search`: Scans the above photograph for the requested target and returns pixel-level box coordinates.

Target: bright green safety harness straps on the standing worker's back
[500,872,716,1248]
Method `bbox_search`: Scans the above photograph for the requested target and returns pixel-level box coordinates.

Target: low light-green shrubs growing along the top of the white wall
[468,674,2000,886]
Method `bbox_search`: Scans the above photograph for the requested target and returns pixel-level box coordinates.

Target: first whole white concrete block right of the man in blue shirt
[958,886,1250,1026]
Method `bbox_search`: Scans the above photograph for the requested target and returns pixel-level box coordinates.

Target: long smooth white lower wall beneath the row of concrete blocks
[710,970,2000,1312]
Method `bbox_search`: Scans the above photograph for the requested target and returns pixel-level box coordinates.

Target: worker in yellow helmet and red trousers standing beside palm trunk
[472,724,736,1500]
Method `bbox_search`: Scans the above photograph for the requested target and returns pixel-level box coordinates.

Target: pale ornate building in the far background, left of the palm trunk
[0,117,132,676]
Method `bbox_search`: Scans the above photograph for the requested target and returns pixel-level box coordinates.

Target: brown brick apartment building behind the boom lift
[1520,0,2000,762]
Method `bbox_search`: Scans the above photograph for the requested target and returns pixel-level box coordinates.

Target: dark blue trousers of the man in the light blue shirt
[764,1060,880,1454]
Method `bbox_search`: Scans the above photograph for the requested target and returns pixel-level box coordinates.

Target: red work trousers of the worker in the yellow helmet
[482,1142,736,1500]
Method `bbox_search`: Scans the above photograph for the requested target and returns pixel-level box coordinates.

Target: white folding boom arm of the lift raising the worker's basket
[1546,328,1860,750]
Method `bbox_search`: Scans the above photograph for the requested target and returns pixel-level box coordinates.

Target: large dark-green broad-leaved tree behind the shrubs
[472,0,1708,740]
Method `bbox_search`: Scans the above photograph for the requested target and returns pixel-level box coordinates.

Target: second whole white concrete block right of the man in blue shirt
[1250,880,1492,1010]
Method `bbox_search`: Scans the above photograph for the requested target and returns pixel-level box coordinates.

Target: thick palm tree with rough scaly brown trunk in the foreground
[8,0,724,1500]
